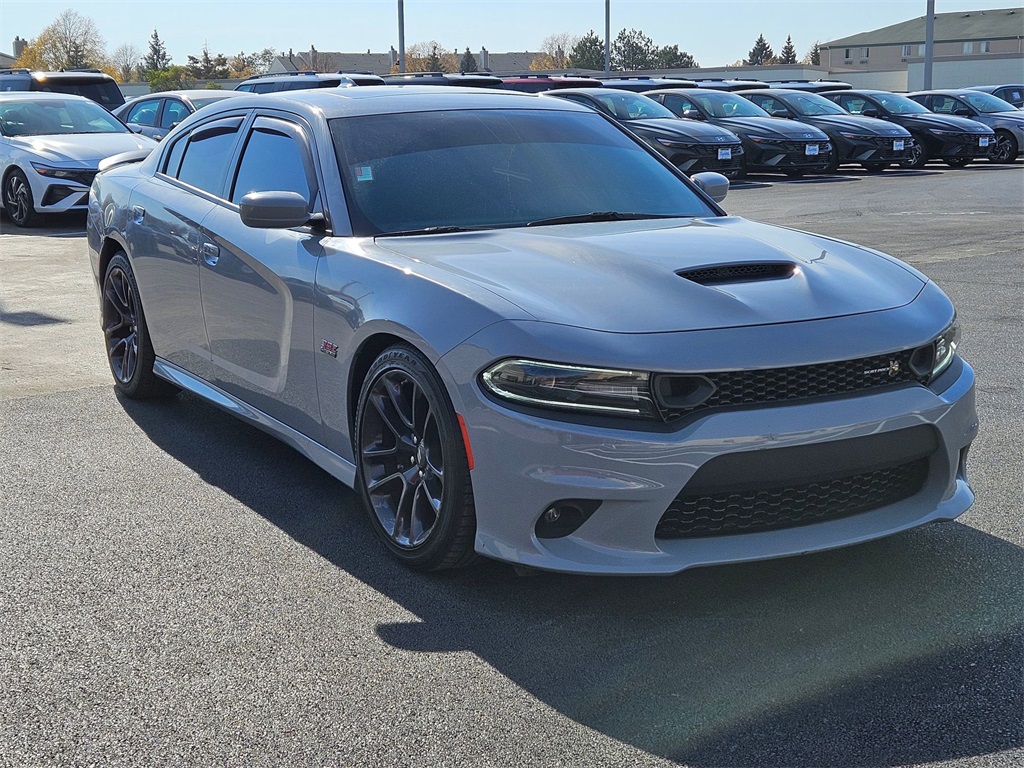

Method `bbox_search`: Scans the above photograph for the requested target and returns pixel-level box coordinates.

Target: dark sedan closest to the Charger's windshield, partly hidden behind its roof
[540,88,743,177]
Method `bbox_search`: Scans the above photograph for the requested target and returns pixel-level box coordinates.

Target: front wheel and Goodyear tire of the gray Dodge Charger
[355,344,476,570]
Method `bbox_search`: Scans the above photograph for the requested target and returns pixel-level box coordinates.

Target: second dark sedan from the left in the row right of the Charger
[646,88,833,177]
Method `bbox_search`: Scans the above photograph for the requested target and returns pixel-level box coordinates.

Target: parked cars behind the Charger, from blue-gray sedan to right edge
[128,72,1024,177]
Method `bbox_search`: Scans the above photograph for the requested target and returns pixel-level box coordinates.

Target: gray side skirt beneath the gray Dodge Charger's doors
[153,357,355,487]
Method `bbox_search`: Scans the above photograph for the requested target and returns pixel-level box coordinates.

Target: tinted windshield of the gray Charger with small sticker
[331,109,716,236]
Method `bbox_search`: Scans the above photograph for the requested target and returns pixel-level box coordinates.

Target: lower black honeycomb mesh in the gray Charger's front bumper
[654,459,928,539]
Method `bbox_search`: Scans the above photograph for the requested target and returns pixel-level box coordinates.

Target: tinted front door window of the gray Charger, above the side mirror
[231,118,312,203]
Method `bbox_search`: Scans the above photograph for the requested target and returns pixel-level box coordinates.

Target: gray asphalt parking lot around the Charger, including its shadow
[0,163,1024,768]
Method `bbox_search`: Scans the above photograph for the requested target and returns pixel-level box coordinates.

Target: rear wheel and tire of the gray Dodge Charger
[100,251,177,399]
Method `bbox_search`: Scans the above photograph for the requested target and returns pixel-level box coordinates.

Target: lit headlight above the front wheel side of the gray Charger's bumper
[480,359,657,419]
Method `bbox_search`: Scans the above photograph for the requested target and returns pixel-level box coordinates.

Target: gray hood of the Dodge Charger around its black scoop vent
[377,217,927,333]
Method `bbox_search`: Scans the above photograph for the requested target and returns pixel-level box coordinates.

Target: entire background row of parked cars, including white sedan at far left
[0,70,1024,226]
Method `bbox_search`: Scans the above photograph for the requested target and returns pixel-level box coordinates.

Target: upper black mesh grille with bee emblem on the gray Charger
[657,348,927,420]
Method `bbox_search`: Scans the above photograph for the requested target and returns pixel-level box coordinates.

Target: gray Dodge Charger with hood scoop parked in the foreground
[88,86,978,573]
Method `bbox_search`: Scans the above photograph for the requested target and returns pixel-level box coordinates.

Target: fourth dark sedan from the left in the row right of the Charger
[821,90,995,168]
